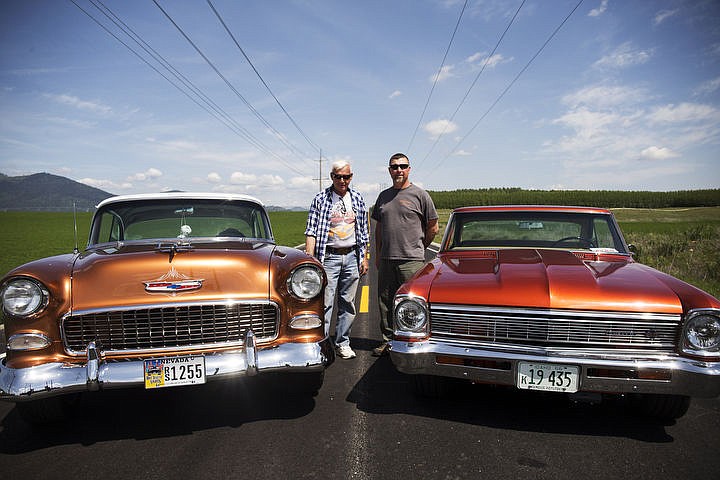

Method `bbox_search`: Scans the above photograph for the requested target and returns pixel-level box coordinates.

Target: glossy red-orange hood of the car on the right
[424,249,682,313]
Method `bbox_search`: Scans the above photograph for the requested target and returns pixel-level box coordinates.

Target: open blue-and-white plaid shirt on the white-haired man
[305,186,370,263]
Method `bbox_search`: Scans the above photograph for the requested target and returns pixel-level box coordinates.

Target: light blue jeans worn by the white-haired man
[323,250,360,347]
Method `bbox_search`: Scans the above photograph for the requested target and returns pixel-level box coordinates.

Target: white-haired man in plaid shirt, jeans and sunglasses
[305,160,369,359]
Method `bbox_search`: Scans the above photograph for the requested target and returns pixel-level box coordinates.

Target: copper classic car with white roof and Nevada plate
[0,193,335,421]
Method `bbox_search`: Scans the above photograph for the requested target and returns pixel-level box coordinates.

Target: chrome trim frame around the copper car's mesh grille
[60,299,280,357]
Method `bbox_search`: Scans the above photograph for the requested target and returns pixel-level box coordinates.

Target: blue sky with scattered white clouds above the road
[0,0,720,207]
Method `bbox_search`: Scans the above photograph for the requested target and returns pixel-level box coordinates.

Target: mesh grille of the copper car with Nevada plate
[62,302,279,353]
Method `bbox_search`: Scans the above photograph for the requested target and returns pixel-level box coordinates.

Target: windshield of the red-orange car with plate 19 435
[443,211,627,253]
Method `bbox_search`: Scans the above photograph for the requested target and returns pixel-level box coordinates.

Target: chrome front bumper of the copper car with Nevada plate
[0,332,335,402]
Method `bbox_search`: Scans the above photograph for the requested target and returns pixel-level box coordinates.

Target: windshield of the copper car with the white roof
[88,199,273,245]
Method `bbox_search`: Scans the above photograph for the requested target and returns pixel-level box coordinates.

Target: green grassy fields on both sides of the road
[0,207,720,297]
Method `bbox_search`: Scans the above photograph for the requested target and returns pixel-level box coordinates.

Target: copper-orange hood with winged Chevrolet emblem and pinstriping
[72,243,274,311]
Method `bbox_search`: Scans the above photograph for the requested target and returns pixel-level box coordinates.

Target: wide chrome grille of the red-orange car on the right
[430,304,680,351]
